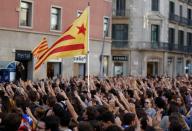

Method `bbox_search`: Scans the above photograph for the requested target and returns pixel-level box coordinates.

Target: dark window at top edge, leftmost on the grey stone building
[116,0,126,16]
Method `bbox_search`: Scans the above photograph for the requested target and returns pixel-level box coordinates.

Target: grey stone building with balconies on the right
[112,0,192,77]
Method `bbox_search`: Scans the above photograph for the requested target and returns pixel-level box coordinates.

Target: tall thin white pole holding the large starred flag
[87,2,90,92]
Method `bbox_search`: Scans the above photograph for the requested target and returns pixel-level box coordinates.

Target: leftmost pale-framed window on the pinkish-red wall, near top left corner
[20,1,32,27]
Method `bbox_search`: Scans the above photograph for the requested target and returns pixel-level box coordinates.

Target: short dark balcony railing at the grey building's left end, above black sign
[112,40,129,49]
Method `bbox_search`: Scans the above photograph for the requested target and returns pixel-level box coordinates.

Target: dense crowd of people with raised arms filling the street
[0,76,192,131]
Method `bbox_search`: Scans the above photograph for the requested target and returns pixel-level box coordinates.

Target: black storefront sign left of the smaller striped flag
[15,50,32,61]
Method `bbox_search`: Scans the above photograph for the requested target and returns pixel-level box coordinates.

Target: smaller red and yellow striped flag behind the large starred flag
[32,38,48,59]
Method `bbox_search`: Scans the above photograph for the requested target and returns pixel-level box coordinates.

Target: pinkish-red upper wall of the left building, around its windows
[0,0,112,39]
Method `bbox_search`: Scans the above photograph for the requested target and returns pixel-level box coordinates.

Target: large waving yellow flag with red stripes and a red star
[35,7,89,70]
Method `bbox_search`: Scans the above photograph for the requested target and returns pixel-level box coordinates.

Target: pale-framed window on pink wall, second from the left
[51,7,61,30]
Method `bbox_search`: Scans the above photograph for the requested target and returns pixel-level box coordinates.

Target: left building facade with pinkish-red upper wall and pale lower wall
[0,0,112,79]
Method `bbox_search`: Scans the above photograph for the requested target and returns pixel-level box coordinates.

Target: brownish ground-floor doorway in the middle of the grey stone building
[147,62,158,76]
